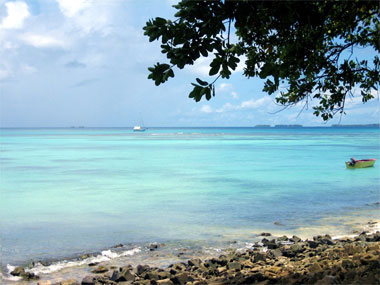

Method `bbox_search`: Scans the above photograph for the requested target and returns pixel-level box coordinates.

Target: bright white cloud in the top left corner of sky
[0,1,30,29]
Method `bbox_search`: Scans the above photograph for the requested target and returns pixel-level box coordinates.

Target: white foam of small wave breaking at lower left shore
[13,247,141,275]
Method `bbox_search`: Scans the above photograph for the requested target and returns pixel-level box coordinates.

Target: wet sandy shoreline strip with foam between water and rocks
[0,216,380,285]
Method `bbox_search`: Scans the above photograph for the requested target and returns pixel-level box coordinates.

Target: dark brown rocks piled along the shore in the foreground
[11,232,380,285]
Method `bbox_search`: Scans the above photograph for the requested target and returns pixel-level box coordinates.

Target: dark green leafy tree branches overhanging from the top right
[144,0,380,120]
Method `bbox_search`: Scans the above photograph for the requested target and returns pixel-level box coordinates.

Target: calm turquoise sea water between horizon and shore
[0,128,380,266]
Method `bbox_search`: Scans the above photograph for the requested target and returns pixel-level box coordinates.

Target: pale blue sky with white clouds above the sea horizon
[0,0,380,127]
